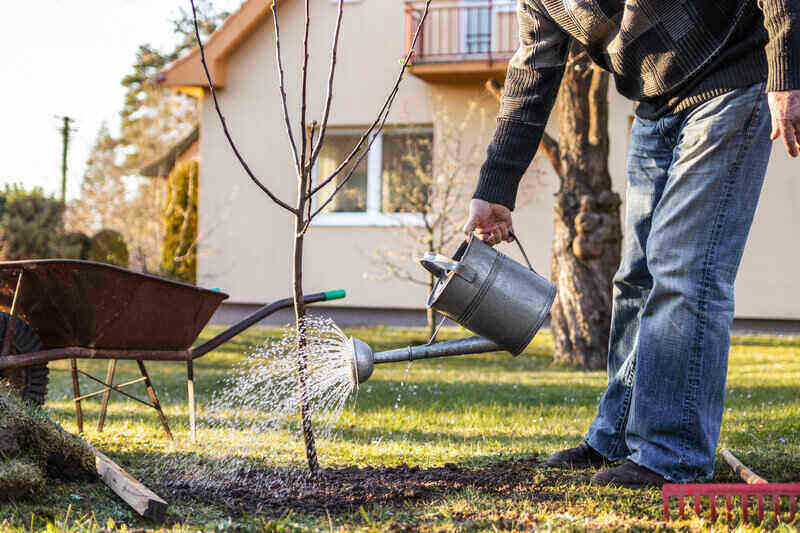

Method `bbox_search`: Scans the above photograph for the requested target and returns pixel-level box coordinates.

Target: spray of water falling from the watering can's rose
[164,317,357,491]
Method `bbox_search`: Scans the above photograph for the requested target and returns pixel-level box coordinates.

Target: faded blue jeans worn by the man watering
[586,83,771,483]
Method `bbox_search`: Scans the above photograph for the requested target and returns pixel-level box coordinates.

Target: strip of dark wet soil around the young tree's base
[169,456,580,515]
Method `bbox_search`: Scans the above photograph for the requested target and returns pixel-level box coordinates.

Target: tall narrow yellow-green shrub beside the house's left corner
[161,161,199,284]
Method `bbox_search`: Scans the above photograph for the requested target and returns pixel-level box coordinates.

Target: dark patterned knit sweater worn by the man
[473,0,800,210]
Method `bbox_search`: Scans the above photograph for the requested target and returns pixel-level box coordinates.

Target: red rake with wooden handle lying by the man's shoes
[661,450,800,522]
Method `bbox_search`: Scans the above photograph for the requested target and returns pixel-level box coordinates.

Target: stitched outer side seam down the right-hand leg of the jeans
[681,84,763,472]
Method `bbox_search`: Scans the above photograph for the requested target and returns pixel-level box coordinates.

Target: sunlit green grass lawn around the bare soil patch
[0,327,800,531]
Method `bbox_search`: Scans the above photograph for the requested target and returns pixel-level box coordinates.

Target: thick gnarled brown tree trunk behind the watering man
[543,49,622,369]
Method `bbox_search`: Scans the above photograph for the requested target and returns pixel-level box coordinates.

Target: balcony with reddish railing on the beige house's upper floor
[406,0,519,83]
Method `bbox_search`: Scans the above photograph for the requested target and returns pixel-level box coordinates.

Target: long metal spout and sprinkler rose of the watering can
[349,336,506,383]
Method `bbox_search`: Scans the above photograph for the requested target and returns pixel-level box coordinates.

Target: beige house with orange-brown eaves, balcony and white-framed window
[163,0,800,323]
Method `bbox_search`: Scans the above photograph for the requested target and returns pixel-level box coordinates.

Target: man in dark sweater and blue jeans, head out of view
[464,0,800,488]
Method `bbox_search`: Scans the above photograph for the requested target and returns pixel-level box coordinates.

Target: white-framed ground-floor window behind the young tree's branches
[314,127,433,226]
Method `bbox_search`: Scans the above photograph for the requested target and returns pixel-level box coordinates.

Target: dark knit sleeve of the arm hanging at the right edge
[758,0,800,92]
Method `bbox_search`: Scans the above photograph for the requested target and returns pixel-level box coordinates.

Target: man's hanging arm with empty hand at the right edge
[758,0,800,157]
